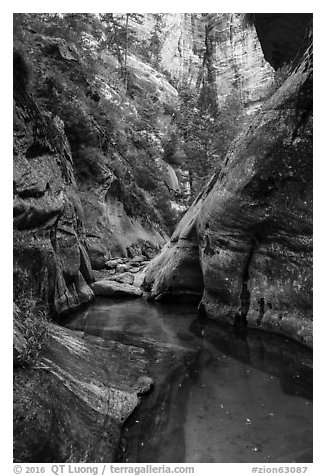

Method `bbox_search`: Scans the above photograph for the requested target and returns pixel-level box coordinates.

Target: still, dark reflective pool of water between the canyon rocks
[68,299,312,463]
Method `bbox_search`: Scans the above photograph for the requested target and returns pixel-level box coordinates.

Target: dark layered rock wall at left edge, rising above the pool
[13,51,93,314]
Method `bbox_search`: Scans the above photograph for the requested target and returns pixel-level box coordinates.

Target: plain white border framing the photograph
[0,0,326,476]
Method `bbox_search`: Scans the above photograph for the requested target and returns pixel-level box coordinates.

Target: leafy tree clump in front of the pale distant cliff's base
[164,86,245,195]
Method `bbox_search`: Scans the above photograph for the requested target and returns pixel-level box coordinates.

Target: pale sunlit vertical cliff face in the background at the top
[141,13,274,112]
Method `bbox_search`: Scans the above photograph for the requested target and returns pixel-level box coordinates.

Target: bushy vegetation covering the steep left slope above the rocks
[15,14,178,236]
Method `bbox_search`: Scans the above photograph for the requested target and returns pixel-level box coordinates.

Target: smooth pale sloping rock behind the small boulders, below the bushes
[79,174,167,269]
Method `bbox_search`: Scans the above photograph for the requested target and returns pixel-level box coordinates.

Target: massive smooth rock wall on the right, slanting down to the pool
[146,16,312,346]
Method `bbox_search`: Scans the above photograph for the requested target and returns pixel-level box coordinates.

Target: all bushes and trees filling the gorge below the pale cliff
[14,13,250,234]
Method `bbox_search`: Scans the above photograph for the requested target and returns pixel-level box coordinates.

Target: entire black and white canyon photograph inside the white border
[11,2,315,470]
